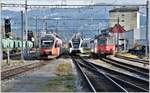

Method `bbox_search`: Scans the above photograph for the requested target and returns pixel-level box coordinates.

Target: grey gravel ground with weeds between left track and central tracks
[1,58,78,92]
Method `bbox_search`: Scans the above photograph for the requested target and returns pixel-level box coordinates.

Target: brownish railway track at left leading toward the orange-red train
[1,62,48,80]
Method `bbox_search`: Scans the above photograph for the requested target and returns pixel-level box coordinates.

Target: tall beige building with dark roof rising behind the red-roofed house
[109,7,140,31]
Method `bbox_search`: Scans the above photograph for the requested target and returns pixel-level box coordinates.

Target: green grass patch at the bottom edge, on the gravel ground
[40,75,75,92]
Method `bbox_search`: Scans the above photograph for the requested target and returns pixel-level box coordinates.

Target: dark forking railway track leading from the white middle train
[72,54,149,92]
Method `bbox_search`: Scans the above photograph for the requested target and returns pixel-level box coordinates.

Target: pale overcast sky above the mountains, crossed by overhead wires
[2,0,147,11]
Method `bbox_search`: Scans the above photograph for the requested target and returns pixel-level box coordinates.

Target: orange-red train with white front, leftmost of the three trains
[40,34,62,58]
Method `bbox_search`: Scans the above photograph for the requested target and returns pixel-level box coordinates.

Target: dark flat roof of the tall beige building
[109,7,139,12]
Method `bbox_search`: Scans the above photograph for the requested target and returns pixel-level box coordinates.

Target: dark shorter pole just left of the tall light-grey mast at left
[21,11,24,62]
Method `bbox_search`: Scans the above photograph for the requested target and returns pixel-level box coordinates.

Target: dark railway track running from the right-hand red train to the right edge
[100,57,149,80]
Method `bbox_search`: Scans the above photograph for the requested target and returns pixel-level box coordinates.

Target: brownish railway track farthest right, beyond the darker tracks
[115,55,149,65]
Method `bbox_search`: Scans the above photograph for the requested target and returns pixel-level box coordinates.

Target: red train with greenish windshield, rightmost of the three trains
[91,35,115,56]
